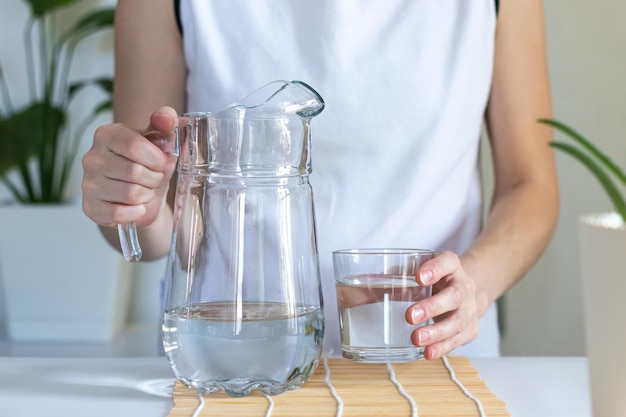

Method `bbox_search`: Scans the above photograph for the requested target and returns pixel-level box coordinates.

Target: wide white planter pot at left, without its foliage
[0,205,131,342]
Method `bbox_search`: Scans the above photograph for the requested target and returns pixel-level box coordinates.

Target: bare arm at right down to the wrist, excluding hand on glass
[462,0,559,315]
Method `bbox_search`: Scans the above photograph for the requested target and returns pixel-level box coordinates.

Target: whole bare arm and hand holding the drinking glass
[407,0,559,358]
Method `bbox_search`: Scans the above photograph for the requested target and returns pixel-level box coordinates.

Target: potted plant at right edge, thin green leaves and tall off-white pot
[540,119,626,417]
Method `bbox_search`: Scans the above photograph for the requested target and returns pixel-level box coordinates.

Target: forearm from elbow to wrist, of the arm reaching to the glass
[461,180,559,316]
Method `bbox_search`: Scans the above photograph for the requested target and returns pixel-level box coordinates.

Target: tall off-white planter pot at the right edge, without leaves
[580,213,626,417]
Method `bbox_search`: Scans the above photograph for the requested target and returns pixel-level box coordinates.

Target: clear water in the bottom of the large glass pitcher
[163,302,323,397]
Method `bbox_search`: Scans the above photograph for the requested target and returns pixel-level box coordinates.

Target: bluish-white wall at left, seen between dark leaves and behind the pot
[0,0,165,331]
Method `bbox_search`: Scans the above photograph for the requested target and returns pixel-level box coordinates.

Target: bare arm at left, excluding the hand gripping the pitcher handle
[100,0,185,261]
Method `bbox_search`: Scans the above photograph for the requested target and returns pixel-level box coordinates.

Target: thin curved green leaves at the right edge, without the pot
[539,119,626,223]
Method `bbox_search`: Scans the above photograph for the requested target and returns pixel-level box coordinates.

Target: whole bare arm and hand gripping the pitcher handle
[83,0,185,260]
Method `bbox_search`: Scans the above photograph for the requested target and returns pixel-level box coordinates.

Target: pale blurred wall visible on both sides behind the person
[0,0,626,356]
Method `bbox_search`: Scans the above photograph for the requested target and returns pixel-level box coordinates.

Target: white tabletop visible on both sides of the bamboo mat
[0,357,591,417]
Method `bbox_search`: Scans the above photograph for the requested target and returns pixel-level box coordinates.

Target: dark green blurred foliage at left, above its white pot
[0,0,114,203]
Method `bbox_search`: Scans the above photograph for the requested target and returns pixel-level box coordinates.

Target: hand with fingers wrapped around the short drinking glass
[406,251,479,359]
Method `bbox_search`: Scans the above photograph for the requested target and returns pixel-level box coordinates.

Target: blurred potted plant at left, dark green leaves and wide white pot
[0,0,128,341]
